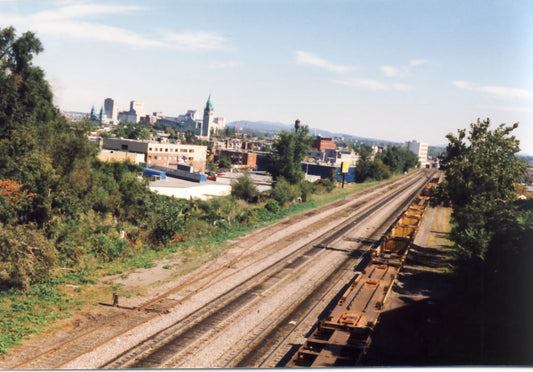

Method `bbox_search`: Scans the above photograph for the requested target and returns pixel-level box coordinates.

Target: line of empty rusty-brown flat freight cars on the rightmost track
[287,178,438,367]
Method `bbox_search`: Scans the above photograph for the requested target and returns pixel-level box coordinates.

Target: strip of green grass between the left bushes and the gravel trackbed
[0,174,404,354]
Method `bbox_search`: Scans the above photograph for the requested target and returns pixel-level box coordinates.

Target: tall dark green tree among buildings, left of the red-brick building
[269,125,313,185]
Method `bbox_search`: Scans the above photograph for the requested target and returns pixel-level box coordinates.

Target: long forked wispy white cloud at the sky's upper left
[0,4,225,50]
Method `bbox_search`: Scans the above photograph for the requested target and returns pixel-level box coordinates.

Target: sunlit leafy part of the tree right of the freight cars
[436,119,526,261]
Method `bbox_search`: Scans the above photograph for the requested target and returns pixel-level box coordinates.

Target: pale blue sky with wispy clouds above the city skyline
[0,0,533,154]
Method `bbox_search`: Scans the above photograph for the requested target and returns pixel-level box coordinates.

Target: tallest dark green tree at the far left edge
[0,27,57,224]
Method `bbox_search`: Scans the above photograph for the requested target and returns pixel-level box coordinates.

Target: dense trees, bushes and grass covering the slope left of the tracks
[0,28,400,353]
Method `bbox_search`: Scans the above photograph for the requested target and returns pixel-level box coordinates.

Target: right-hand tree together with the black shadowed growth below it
[436,119,533,365]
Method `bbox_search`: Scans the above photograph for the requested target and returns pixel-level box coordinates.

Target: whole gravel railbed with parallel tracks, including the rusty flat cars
[3,170,436,369]
